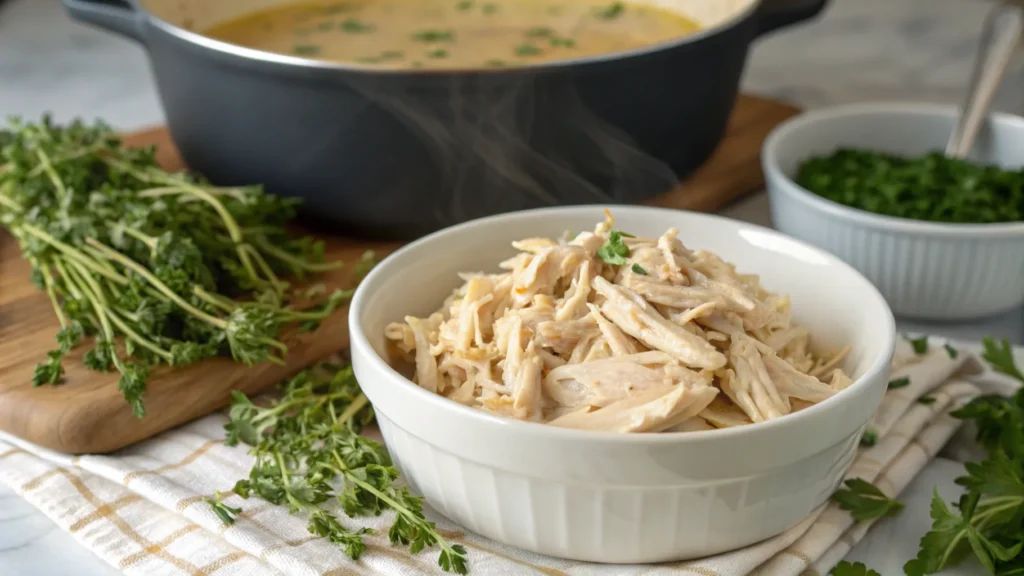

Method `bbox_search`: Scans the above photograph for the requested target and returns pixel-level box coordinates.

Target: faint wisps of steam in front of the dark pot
[351,73,678,229]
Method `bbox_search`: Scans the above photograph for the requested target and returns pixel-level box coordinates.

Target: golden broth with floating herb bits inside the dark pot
[204,0,699,69]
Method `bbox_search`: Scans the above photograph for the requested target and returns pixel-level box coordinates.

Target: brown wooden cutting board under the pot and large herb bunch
[0,96,798,454]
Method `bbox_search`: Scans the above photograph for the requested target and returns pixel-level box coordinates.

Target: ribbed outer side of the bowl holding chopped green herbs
[768,183,1024,320]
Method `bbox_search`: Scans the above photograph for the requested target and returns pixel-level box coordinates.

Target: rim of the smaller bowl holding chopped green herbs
[761,101,1024,238]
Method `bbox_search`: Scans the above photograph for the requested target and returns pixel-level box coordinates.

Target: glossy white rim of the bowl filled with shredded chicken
[348,205,896,445]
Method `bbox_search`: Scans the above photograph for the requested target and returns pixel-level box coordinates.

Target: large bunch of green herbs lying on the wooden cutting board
[0,118,348,417]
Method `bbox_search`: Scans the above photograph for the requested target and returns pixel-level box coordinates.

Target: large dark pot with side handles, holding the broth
[63,0,825,239]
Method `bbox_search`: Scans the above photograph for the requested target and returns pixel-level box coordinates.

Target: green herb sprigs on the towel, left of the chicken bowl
[225,364,468,574]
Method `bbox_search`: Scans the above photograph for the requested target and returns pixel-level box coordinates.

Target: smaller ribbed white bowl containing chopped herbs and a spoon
[762,104,1024,320]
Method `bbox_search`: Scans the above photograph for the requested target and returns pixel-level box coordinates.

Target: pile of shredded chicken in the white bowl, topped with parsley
[385,214,853,433]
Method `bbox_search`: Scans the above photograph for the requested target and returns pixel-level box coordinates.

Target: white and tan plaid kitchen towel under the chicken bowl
[0,336,1011,576]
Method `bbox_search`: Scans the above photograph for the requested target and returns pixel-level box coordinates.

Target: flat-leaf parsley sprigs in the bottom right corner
[903,338,1024,576]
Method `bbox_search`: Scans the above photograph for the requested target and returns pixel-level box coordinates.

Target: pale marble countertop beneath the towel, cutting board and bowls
[0,0,1024,576]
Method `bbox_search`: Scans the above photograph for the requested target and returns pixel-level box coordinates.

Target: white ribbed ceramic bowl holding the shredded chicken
[349,206,895,563]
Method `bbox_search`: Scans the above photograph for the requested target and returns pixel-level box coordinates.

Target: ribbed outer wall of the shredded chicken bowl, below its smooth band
[377,411,860,564]
